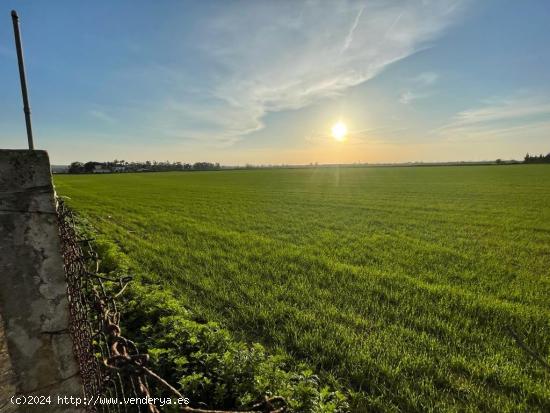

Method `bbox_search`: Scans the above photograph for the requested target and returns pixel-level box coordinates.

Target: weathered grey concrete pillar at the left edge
[0,150,82,413]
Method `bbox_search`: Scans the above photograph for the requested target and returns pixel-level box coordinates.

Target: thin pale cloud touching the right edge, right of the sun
[433,96,550,141]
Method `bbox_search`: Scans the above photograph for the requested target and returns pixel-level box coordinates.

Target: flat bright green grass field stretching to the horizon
[55,165,550,411]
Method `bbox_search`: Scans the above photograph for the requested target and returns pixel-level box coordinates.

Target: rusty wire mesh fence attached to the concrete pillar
[57,198,287,413]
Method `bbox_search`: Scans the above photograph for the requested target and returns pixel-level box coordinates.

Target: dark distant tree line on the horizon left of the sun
[68,159,221,174]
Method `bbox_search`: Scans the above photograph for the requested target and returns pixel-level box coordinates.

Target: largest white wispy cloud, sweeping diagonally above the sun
[159,0,464,144]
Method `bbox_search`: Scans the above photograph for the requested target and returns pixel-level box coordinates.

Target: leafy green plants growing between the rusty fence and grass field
[88,233,349,413]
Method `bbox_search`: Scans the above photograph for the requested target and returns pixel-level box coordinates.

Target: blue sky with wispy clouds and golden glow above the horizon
[0,0,550,165]
